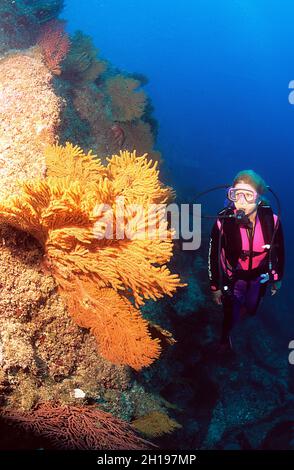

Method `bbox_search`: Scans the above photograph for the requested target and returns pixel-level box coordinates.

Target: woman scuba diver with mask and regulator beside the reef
[208,170,284,352]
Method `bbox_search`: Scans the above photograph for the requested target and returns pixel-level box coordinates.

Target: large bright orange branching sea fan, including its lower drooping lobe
[0,143,184,370]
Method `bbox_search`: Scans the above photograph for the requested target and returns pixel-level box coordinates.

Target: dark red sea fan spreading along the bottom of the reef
[1,402,155,450]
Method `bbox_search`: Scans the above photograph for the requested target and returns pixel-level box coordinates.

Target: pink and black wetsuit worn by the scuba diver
[208,205,284,342]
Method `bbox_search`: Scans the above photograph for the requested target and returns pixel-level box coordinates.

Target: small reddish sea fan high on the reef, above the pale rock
[37,20,70,75]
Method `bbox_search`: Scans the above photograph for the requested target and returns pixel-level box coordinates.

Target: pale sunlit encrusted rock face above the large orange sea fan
[0,48,62,197]
